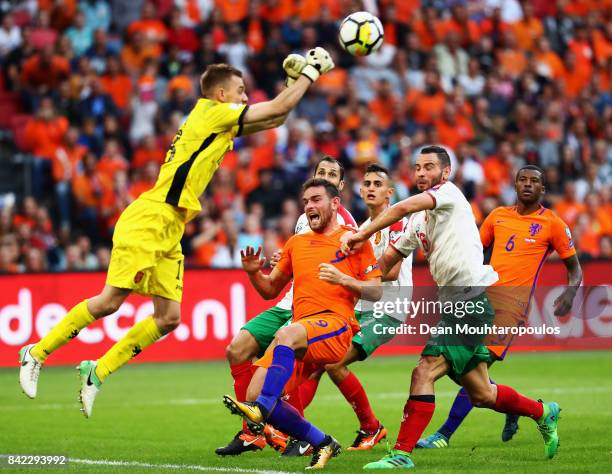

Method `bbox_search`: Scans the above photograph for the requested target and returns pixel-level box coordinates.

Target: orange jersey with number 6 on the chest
[480,206,576,287]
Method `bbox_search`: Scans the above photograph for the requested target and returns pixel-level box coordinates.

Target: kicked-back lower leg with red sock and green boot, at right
[461,362,561,459]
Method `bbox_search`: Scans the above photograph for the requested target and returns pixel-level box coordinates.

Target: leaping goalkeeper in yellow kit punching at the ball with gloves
[19,48,334,417]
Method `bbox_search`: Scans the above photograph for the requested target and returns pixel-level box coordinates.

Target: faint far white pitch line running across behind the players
[0,386,612,411]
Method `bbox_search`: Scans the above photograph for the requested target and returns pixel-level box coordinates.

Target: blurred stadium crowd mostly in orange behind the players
[0,0,612,273]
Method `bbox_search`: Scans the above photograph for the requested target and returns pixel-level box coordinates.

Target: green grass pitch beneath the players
[0,352,612,473]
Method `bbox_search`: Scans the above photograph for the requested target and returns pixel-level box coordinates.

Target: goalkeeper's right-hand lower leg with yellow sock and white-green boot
[77,296,176,418]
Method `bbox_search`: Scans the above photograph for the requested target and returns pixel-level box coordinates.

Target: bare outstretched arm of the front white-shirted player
[342,193,435,253]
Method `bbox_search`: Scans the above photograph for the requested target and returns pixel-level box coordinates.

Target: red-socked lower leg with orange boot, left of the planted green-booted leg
[325,345,387,451]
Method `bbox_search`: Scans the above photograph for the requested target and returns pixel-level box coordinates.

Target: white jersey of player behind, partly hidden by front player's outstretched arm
[355,217,412,321]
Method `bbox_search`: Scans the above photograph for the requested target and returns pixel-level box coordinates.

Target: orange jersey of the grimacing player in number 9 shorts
[277,226,382,333]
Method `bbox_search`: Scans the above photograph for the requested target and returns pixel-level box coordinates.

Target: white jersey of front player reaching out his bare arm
[394,181,498,299]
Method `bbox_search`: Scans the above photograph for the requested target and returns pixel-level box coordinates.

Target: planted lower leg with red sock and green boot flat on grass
[363,356,450,469]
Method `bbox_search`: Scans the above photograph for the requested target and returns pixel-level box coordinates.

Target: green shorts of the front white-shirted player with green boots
[421,293,495,383]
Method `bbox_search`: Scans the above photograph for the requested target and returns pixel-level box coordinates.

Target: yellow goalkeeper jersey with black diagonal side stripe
[140,99,248,222]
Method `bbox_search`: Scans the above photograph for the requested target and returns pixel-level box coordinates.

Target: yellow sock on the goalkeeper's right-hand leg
[96,316,161,382]
